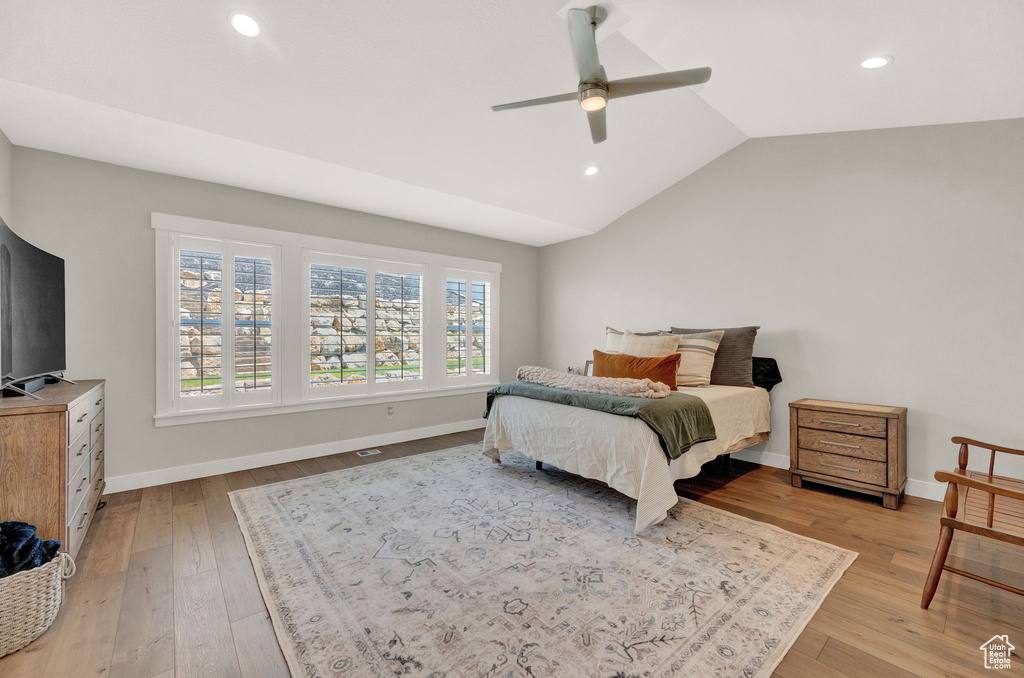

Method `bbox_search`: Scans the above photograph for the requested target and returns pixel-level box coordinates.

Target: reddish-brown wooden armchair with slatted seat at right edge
[921,437,1024,609]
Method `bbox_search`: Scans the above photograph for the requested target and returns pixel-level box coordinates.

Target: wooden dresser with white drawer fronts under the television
[0,379,104,557]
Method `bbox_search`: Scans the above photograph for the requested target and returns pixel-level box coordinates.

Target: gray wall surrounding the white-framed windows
[13,146,539,476]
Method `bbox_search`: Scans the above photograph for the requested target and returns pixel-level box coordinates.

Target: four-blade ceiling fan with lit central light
[490,5,711,143]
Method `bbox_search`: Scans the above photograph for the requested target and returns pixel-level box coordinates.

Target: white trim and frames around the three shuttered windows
[152,212,502,426]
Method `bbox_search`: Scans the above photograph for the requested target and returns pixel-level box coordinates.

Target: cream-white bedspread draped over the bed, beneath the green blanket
[483,386,771,533]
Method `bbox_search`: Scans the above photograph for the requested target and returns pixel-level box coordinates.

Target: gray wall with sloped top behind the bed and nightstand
[541,120,1024,493]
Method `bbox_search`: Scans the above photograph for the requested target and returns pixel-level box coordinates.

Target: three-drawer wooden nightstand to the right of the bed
[790,398,906,510]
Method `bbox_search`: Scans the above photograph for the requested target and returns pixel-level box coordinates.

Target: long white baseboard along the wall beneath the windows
[106,419,484,495]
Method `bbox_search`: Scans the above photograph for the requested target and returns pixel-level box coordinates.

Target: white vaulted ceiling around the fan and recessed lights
[0,0,1024,245]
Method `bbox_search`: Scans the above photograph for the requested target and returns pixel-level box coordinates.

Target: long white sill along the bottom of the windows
[153,381,498,426]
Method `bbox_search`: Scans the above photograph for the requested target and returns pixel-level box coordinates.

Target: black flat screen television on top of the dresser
[0,219,67,386]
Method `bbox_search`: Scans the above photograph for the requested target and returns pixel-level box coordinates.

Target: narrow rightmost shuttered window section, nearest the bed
[444,268,496,384]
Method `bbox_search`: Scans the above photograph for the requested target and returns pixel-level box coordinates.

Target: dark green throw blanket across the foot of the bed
[483,381,716,461]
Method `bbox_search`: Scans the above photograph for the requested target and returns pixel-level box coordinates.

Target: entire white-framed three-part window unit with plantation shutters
[153,214,501,425]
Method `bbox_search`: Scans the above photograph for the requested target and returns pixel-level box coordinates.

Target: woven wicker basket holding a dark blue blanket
[0,553,75,656]
